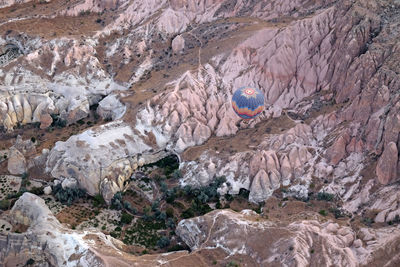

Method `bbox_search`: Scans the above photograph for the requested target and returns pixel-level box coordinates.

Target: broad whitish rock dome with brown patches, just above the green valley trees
[46,120,167,202]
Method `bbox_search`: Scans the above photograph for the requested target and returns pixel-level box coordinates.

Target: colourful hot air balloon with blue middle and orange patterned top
[232,87,264,119]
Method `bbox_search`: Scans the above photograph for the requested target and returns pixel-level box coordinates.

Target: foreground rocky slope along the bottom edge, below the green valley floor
[0,193,400,266]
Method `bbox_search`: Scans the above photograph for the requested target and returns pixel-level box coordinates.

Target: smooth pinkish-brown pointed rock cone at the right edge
[376,142,398,185]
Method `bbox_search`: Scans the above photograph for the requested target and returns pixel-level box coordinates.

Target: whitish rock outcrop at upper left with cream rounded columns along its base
[0,37,126,131]
